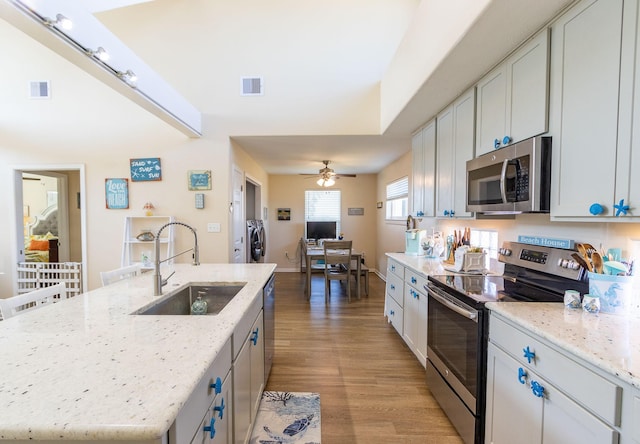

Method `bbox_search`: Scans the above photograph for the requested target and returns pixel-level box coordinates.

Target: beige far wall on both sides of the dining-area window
[265,174,380,271]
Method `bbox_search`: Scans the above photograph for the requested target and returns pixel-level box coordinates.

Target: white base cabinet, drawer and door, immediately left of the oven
[403,268,427,367]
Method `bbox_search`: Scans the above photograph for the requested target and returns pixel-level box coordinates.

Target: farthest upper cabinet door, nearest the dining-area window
[411,119,436,217]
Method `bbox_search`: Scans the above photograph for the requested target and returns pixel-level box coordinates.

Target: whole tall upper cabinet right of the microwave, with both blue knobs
[549,0,640,220]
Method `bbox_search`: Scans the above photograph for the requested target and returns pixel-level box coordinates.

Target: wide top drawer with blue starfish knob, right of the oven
[489,314,622,426]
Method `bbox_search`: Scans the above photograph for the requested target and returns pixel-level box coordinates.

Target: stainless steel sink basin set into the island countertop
[131,282,246,315]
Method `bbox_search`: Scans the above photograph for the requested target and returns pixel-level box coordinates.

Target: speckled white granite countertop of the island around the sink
[0,264,275,441]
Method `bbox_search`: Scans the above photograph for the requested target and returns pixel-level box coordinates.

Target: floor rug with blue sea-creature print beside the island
[249,391,321,444]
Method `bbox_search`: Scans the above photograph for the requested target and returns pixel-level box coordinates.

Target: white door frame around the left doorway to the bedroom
[9,164,89,294]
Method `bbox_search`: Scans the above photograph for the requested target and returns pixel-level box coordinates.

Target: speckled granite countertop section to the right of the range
[487,302,640,388]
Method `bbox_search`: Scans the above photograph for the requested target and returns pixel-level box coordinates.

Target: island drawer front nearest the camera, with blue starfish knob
[169,339,231,443]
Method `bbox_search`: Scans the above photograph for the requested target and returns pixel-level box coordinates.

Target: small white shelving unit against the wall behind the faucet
[121,216,175,270]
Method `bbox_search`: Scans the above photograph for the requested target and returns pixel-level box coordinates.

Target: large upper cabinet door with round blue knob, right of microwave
[551,0,622,216]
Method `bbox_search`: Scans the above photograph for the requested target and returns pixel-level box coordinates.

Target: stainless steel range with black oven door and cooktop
[425,242,588,444]
